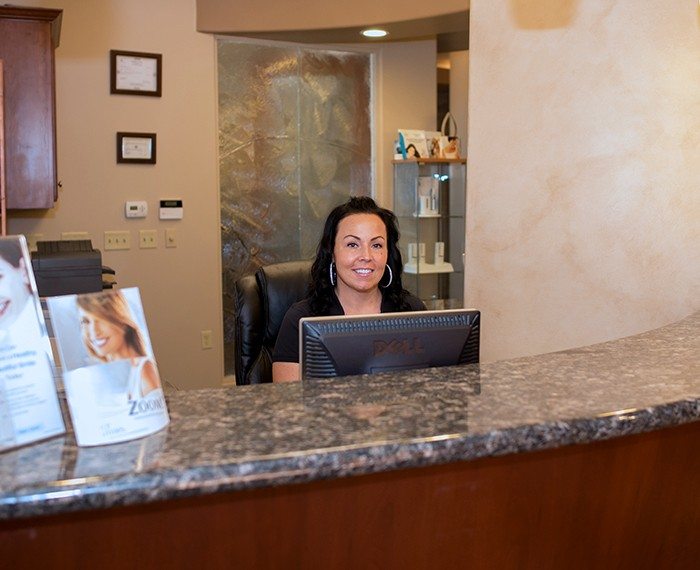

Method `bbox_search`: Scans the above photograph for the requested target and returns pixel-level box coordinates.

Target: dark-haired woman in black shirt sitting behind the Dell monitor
[272,196,425,382]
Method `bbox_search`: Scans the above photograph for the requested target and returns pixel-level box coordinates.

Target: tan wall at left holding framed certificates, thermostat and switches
[9,0,223,388]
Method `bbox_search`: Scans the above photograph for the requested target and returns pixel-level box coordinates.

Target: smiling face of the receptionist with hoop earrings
[333,214,388,292]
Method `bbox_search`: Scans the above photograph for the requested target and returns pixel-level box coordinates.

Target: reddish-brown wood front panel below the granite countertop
[0,422,700,569]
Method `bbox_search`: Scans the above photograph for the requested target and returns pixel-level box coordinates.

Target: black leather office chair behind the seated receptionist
[234,261,311,385]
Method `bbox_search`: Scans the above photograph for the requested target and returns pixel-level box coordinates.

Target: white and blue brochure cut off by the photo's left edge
[0,236,65,451]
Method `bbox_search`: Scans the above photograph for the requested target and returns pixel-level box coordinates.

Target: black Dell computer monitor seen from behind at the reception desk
[299,309,480,379]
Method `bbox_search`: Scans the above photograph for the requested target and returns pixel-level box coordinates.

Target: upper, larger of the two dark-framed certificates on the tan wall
[109,50,163,97]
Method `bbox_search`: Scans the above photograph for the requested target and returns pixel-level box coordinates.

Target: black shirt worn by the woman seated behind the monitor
[272,294,425,362]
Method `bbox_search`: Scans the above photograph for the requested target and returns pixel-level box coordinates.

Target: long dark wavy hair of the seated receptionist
[309,196,410,310]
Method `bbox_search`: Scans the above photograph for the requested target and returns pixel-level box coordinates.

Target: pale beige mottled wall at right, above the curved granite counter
[466,0,700,360]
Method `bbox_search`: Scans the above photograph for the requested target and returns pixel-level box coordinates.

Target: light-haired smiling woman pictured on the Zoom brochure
[77,291,160,401]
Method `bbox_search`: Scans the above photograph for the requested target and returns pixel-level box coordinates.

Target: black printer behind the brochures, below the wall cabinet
[32,239,114,297]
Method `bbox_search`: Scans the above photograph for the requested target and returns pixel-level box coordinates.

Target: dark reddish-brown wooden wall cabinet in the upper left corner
[0,6,63,209]
